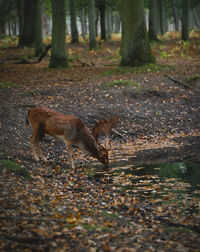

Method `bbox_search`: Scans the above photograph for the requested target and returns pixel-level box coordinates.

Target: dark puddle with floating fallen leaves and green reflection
[101,161,200,213]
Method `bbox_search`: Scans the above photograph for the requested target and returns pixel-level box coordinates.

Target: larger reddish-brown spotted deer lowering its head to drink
[26,107,109,169]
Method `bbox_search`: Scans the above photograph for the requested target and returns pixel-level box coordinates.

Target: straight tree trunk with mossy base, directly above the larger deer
[49,0,68,68]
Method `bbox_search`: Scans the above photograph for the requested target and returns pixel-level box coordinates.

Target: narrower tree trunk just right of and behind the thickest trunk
[149,0,160,41]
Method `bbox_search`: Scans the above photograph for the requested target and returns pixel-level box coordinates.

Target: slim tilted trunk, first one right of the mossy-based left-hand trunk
[70,0,79,44]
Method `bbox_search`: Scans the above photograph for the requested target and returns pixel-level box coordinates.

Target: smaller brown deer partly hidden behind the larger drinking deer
[92,115,119,148]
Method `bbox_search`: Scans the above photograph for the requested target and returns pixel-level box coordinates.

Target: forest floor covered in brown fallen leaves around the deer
[0,33,200,252]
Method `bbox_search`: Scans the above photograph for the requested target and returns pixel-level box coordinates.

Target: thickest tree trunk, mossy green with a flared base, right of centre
[120,0,155,66]
